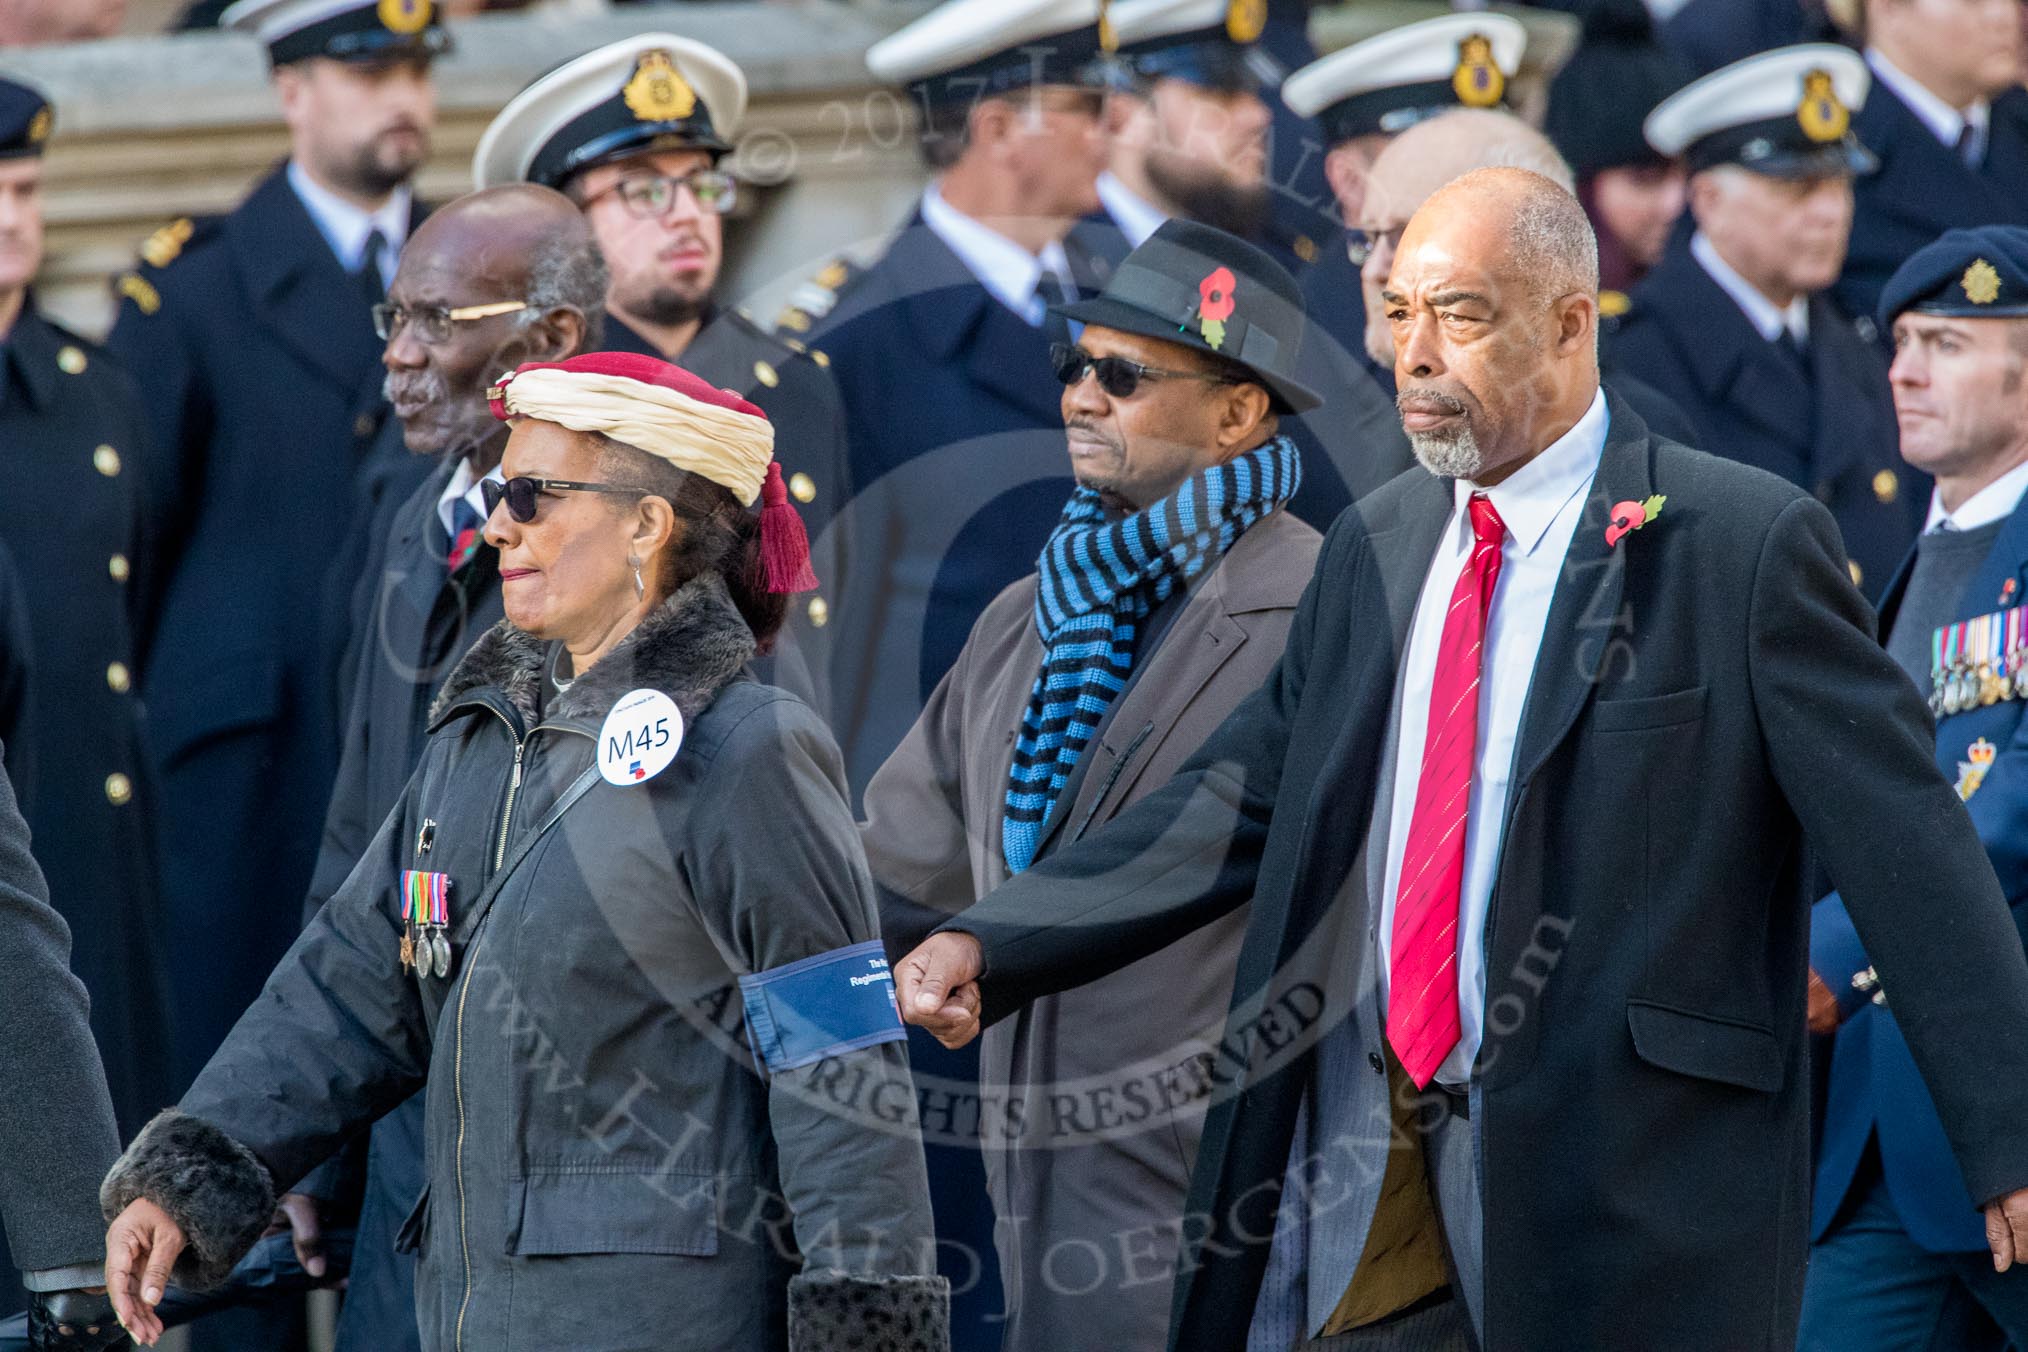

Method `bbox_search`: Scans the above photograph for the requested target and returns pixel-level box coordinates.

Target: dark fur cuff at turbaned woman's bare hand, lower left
[99,1109,274,1291]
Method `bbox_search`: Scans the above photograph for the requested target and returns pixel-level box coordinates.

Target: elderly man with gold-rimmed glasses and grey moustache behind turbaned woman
[278,184,606,1352]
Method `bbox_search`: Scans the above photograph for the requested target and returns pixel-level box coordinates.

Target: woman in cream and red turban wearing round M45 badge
[103,353,947,1352]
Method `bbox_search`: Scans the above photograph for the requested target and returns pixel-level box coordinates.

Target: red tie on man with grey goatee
[1387,493,1507,1088]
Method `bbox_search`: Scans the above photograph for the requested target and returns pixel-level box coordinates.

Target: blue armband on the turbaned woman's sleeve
[740,938,909,1074]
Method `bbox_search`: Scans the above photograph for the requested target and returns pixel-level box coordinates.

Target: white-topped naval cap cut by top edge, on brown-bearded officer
[1099,0,1286,91]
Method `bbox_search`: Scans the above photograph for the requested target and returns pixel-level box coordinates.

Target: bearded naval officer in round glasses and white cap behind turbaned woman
[473,32,850,705]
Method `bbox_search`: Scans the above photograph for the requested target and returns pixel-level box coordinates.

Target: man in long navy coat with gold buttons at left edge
[0,79,174,1131]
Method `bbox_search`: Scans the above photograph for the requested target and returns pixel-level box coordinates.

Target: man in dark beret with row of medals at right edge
[1797,225,2028,1352]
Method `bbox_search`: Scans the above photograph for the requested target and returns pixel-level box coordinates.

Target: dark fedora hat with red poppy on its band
[1051,217,1324,414]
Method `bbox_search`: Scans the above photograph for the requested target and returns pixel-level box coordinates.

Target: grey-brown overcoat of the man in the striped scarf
[862,502,1320,1352]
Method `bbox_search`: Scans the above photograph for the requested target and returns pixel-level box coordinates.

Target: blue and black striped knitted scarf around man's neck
[1000,436,1302,874]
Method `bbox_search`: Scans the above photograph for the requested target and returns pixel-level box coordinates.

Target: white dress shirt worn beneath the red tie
[1373,391,1606,1086]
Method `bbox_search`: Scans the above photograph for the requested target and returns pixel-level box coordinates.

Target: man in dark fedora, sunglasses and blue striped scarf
[862,219,1318,1352]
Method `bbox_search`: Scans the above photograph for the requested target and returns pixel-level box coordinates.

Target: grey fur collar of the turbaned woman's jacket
[430,574,754,722]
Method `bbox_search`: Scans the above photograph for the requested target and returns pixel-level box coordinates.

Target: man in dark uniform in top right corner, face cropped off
[1837,0,2028,314]
